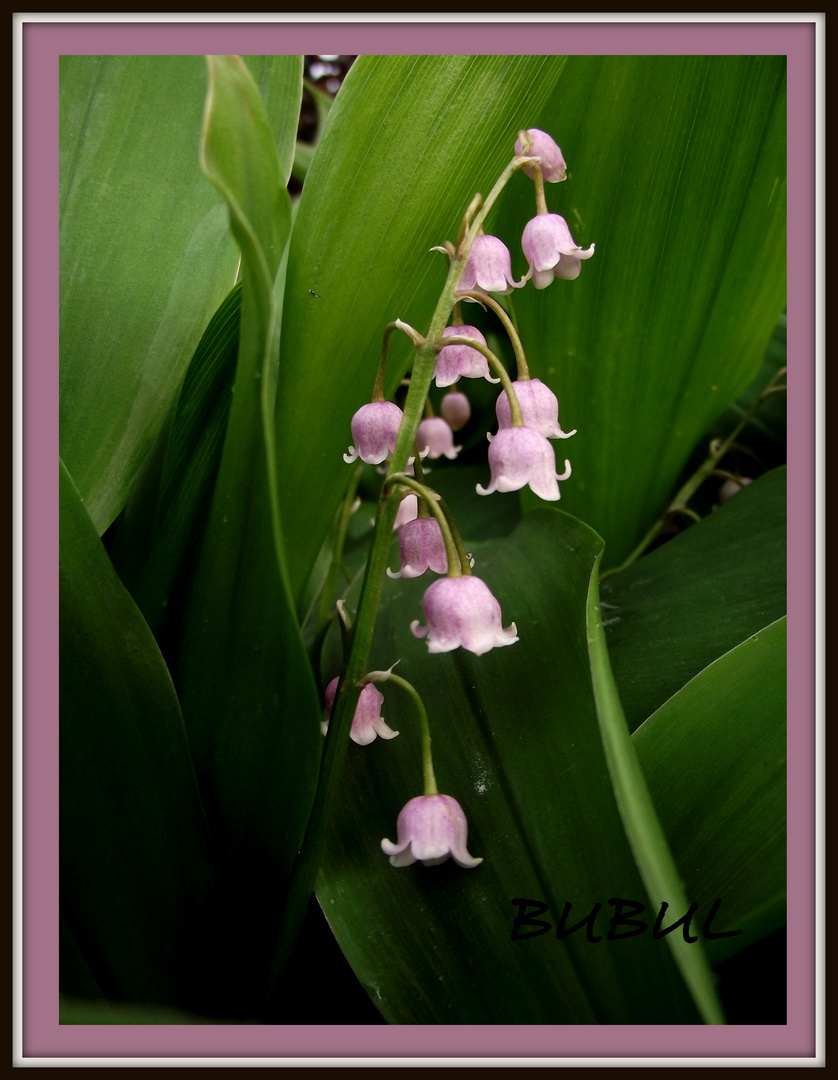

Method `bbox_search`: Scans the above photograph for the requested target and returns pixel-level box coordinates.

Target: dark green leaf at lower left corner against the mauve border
[59,463,213,1008]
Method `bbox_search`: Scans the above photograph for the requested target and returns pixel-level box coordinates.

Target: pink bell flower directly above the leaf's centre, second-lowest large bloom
[410,575,518,657]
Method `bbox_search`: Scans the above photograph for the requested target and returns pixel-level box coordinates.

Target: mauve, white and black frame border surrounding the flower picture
[13,13,824,1066]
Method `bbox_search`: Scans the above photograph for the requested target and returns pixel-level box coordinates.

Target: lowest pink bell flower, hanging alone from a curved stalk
[381,795,483,869]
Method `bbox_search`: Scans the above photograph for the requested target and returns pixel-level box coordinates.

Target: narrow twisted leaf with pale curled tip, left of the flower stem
[177,57,321,1015]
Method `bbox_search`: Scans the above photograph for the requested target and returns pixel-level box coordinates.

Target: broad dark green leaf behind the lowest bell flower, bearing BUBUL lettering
[317,510,713,1024]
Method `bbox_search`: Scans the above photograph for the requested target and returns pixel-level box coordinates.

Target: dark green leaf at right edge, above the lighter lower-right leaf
[602,468,786,730]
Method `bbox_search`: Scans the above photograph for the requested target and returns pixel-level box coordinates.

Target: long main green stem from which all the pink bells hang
[269,147,539,1003]
